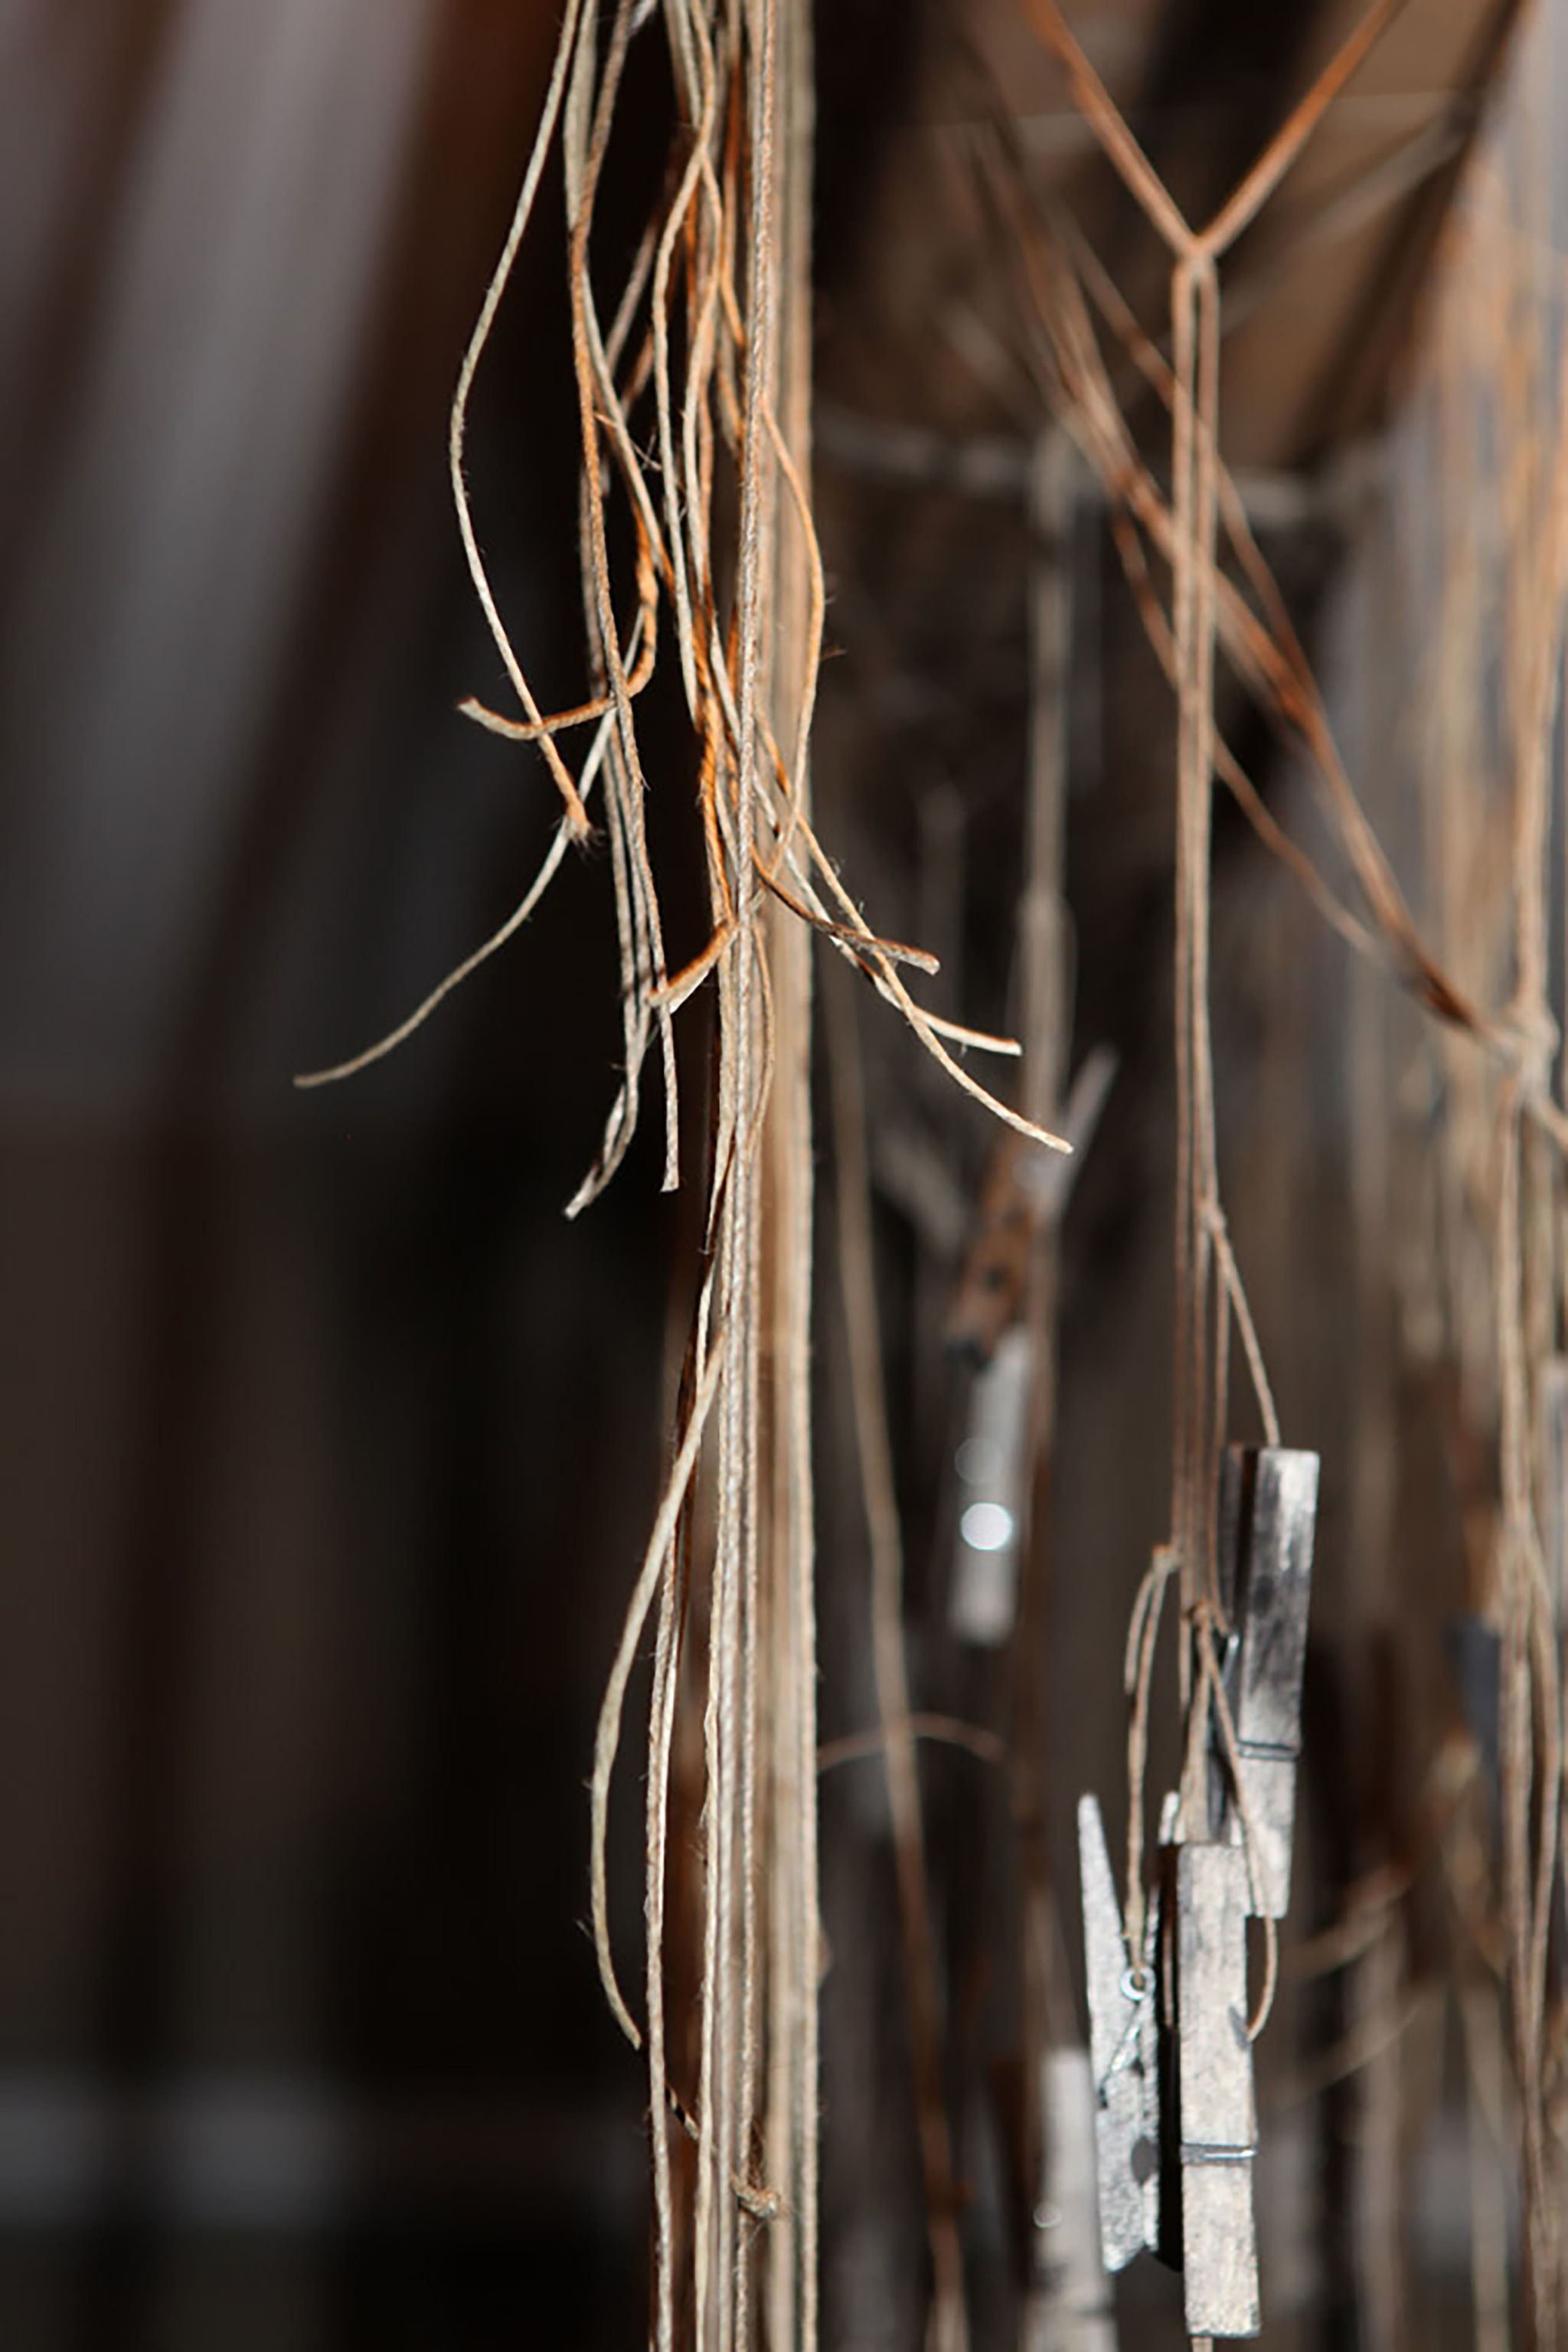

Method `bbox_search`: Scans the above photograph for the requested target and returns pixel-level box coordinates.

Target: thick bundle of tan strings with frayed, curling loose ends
[301,0,1065,2352]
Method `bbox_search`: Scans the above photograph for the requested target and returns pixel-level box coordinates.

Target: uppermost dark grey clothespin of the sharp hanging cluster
[1208,1446,1319,1919]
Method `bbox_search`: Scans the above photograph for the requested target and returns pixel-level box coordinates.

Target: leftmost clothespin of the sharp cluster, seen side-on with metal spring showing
[1079,1797,1161,2269]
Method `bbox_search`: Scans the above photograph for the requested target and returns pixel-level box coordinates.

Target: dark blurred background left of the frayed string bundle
[0,0,672,2352]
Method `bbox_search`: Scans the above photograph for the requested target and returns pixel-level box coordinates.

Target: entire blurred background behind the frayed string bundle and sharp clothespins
[0,0,1568,2352]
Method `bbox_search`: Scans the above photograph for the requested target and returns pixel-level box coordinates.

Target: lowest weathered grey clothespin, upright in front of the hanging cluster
[1175,1844,1263,2335]
